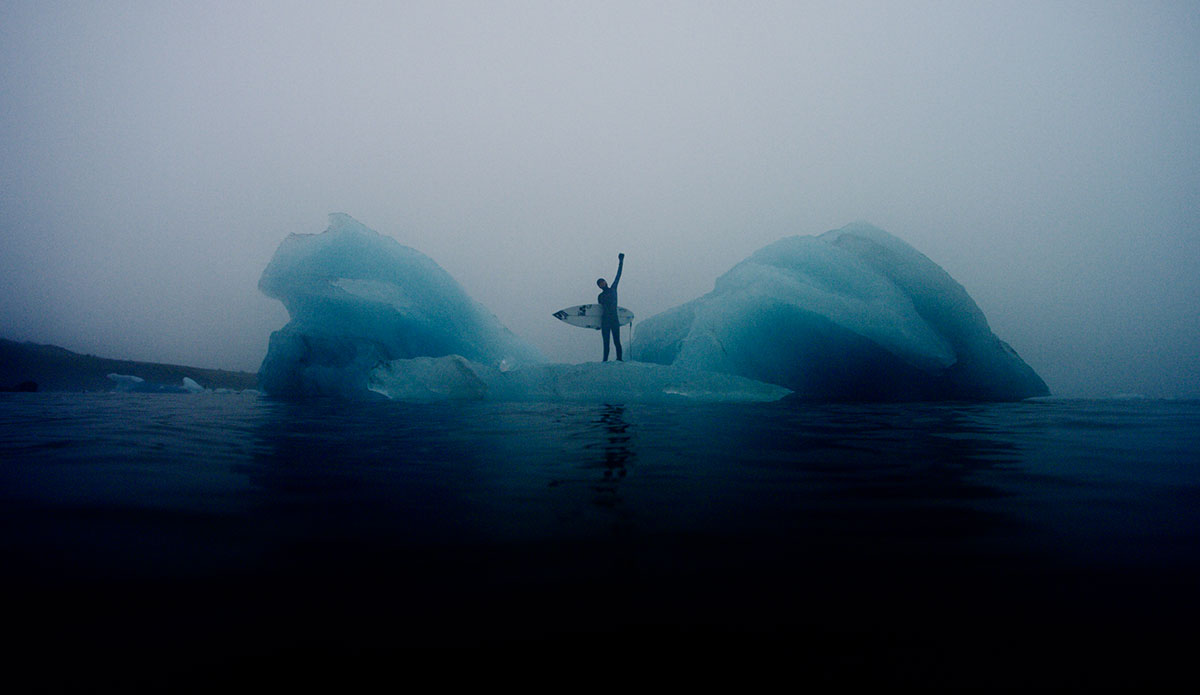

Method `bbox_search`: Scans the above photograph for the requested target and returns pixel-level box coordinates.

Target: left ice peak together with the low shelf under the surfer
[259,215,790,402]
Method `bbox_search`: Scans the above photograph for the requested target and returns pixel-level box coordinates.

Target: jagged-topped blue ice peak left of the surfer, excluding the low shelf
[258,214,544,396]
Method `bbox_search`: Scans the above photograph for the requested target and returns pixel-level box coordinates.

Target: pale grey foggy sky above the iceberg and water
[0,0,1200,396]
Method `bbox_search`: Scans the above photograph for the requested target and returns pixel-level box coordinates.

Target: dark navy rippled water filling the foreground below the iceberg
[0,394,1200,690]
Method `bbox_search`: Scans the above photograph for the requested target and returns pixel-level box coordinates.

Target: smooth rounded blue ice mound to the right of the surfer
[634,223,1049,400]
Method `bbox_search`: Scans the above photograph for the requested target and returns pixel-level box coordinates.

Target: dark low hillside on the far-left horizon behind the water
[0,338,258,391]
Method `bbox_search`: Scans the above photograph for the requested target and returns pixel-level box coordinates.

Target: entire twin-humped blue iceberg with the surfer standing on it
[260,215,1048,402]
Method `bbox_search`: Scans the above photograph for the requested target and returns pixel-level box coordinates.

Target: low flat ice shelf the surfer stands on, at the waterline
[370,355,791,403]
